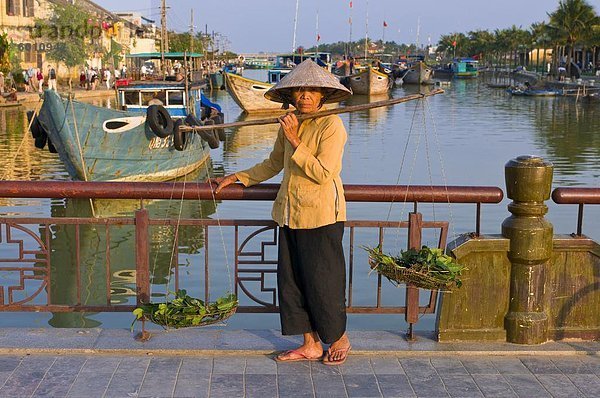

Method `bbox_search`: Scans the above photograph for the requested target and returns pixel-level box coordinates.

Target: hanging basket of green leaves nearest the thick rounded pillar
[365,246,465,291]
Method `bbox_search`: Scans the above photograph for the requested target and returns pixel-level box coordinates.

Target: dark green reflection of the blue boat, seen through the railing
[38,167,216,327]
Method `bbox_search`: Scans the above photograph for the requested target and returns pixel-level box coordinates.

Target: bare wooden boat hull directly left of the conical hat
[224,73,292,113]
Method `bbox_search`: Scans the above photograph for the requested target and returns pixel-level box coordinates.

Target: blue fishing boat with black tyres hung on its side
[31,53,224,181]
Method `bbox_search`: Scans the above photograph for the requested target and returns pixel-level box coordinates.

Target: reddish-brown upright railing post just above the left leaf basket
[135,209,150,305]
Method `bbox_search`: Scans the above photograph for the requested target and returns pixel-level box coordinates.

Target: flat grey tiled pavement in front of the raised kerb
[0,354,600,398]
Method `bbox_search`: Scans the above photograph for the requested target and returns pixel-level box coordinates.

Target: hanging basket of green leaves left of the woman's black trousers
[132,290,239,329]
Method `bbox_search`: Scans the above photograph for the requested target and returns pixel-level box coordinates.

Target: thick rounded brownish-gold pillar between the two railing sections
[502,156,553,344]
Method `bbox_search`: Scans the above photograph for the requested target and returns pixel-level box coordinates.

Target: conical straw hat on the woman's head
[265,59,352,104]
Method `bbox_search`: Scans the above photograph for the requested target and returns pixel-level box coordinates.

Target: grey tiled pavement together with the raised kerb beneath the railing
[0,329,600,398]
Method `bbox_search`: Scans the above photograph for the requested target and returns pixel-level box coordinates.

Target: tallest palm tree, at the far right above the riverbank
[548,0,598,75]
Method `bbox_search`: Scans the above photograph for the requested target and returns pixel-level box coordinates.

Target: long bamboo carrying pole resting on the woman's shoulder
[179,88,444,132]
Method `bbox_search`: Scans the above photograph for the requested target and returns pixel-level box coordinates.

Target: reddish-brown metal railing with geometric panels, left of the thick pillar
[0,181,503,332]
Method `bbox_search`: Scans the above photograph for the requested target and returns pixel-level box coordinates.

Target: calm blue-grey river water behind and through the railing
[0,71,600,330]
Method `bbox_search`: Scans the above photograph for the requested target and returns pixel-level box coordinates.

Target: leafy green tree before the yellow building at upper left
[32,3,94,89]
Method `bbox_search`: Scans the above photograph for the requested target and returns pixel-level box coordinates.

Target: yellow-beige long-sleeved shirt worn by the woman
[236,115,347,229]
